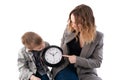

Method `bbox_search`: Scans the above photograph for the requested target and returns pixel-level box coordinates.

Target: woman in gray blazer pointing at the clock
[52,4,103,80]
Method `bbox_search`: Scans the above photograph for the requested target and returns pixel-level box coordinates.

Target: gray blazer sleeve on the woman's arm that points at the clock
[75,34,103,68]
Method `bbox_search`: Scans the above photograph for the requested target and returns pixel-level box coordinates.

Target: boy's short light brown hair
[21,32,43,50]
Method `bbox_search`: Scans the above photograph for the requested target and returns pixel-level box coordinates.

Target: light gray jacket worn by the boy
[18,42,49,80]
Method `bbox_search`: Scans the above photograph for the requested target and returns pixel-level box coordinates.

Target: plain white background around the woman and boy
[0,0,120,80]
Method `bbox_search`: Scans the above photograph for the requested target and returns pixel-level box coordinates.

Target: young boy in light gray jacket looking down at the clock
[18,32,49,80]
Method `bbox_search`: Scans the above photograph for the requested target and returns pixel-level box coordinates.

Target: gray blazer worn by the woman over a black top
[52,29,103,80]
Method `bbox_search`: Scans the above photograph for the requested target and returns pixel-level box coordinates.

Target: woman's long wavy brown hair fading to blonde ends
[68,4,96,44]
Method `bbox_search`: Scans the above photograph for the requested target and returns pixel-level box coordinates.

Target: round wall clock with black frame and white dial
[43,46,63,66]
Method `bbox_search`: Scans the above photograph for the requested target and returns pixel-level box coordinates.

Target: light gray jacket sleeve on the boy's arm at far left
[18,50,33,80]
